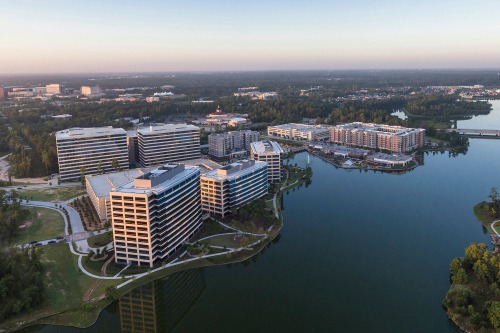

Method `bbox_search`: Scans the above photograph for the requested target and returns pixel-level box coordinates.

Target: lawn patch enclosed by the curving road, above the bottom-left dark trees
[13,207,64,245]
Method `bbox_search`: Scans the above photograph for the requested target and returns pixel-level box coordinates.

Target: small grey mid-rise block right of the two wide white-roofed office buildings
[208,130,260,159]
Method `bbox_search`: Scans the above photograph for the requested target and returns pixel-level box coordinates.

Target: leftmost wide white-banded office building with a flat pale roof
[56,126,129,181]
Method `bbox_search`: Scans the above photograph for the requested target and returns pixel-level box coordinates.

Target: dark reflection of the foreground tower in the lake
[119,269,205,333]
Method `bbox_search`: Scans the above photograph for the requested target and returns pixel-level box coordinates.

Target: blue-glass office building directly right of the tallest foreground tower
[201,160,267,217]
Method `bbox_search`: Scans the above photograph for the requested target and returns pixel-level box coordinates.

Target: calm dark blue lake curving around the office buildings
[29,101,500,332]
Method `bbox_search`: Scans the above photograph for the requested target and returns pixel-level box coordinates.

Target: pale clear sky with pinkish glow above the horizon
[0,0,500,74]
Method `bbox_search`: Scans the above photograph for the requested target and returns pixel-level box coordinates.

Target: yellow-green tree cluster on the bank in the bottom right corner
[443,243,500,332]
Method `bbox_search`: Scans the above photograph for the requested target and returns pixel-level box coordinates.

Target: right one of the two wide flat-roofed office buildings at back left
[137,124,200,167]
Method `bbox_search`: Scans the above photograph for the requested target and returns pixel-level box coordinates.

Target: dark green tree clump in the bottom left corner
[0,248,44,322]
